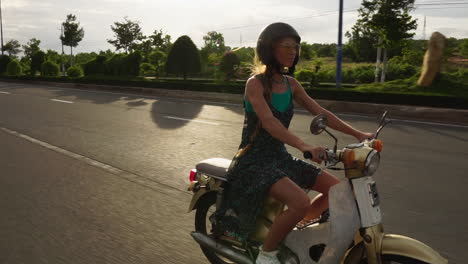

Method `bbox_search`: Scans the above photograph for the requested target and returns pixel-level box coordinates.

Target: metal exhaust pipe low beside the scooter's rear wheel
[190,232,252,264]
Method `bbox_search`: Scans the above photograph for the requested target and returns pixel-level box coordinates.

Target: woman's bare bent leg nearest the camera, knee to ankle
[263,177,311,251]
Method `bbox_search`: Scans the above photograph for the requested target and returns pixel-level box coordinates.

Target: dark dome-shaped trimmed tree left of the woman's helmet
[166,36,201,80]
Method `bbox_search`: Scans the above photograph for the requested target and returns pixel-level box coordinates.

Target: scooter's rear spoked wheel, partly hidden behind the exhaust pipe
[195,195,245,264]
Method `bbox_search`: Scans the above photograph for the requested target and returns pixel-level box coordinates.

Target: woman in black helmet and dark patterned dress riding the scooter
[215,23,374,263]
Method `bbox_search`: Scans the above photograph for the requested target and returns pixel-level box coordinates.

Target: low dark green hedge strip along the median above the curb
[1,73,468,109]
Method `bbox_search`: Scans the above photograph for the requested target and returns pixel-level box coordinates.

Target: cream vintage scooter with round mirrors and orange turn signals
[188,112,448,264]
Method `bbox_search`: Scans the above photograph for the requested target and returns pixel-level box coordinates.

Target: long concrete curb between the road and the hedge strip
[2,80,468,125]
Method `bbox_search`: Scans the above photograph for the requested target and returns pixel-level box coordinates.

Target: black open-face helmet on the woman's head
[256,22,301,70]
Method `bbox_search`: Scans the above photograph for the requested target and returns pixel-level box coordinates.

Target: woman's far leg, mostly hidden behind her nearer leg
[304,171,340,221]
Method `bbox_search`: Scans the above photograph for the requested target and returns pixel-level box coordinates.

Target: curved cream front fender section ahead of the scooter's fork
[382,234,448,264]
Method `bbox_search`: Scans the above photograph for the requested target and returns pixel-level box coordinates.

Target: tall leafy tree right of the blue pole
[355,0,417,82]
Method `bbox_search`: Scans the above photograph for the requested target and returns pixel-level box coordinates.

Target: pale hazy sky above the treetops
[1,0,468,54]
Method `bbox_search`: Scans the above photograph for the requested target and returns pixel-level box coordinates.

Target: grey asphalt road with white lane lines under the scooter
[0,82,468,264]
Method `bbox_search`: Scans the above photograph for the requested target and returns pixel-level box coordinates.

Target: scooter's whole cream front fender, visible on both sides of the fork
[341,234,448,264]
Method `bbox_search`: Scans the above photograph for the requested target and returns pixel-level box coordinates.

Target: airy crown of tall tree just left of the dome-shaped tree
[107,17,144,53]
